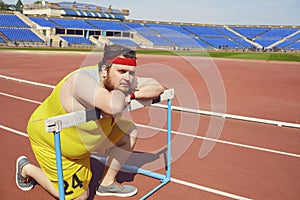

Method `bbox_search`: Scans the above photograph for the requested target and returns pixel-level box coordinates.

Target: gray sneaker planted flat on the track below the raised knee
[96,183,137,197]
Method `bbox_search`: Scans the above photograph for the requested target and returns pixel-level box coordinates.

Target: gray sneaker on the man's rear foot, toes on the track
[16,156,34,191]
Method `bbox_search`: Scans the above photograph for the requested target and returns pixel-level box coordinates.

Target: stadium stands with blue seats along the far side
[0,1,300,51]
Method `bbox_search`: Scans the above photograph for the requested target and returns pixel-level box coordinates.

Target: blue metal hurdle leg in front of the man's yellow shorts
[54,131,65,200]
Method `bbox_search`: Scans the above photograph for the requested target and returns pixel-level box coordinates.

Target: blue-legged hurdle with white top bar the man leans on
[45,89,175,200]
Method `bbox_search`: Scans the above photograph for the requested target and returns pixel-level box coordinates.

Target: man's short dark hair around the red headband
[98,44,137,68]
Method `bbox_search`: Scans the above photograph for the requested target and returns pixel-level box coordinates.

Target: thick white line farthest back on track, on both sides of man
[0,74,300,128]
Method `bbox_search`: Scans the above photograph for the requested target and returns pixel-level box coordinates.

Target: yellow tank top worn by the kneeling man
[27,66,112,159]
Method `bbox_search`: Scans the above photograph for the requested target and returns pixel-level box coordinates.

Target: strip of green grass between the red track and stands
[0,48,300,62]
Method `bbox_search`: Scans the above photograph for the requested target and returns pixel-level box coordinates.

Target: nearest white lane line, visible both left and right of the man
[0,125,250,200]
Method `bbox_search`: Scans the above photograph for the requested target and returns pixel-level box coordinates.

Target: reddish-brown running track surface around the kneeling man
[0,51,300,200]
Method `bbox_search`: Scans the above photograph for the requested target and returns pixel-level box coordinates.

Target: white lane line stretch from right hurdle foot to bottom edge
[171,178,251,200]
